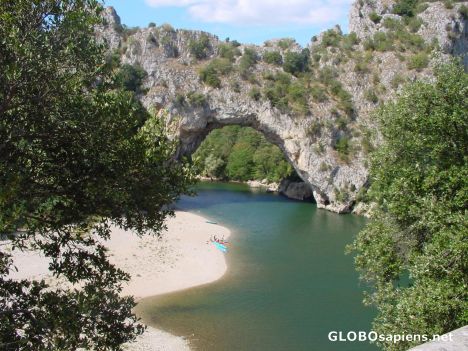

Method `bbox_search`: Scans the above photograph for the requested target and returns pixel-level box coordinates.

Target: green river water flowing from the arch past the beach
[137,183,376,351]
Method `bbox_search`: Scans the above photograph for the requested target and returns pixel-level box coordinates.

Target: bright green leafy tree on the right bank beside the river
[353,63,468,350]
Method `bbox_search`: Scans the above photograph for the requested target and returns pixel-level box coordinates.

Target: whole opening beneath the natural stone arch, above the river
[191,125,315,202]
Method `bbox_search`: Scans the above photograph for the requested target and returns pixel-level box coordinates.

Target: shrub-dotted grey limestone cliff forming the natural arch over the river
[98,0,468,213]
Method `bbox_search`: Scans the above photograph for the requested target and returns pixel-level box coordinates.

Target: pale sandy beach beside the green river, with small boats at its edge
[3,211,230,351]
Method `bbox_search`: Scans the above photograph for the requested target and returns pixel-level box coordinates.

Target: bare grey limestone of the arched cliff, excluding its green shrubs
[98,0,468,213]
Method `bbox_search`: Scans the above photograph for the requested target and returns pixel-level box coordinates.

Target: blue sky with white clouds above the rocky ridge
[104,0,353,46]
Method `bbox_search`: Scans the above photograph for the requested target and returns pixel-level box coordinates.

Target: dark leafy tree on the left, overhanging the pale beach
[0,0,191,350]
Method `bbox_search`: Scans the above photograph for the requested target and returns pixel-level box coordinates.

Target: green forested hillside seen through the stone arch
[193,126,294,182]
